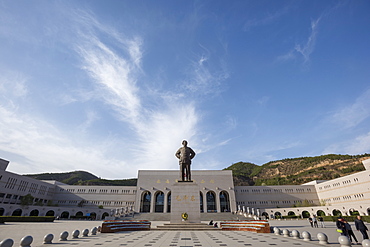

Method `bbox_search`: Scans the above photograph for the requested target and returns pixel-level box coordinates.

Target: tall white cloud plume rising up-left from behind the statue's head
[70,10,199,172]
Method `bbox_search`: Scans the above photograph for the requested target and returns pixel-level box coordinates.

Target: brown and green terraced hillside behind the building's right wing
[224,154,370,186]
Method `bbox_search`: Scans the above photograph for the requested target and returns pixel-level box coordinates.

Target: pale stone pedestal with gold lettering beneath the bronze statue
[170,181,200,224]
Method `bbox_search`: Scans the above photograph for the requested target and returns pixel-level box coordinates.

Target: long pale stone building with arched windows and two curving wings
[0,159,370,220]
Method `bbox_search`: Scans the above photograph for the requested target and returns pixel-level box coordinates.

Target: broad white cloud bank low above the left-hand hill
[0,102,127,177]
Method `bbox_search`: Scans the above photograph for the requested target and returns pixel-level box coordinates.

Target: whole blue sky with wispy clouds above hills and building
[0,0,370,179]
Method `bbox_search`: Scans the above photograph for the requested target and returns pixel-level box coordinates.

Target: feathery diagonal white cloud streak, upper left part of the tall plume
[77,37,141,121]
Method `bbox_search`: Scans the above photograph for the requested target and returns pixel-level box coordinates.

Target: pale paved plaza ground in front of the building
[0,220,362,247]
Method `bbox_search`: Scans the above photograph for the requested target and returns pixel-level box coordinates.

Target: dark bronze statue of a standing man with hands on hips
[175,140,195,181]
